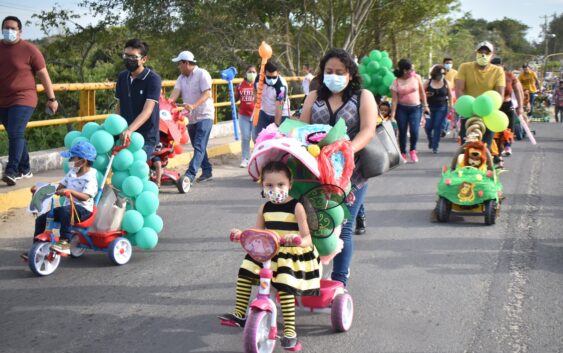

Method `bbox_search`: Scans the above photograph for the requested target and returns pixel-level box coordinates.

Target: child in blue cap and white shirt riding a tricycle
[35,141,98,255]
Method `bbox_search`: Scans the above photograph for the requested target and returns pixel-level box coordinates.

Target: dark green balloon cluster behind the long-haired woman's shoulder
[358,50,395,96]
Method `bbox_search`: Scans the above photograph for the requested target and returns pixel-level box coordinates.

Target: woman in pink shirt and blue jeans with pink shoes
[390,59,428,163]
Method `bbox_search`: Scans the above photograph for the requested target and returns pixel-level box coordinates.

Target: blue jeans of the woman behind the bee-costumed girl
[331,184,368,285]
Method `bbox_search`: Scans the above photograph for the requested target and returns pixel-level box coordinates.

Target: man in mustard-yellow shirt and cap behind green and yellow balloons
[455,41,506,149]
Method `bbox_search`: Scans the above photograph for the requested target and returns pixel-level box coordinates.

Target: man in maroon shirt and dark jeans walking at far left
[0,16,59,186]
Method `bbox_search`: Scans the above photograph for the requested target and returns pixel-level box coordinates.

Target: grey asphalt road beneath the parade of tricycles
[0,124,563,353]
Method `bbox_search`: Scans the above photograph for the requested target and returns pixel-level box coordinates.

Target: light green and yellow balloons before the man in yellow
[454,91,508,132]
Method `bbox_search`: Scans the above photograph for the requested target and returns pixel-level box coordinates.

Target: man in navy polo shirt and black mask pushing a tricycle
[115,39,162,158]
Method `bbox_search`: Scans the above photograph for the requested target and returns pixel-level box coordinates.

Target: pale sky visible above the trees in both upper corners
[0,0,563,41]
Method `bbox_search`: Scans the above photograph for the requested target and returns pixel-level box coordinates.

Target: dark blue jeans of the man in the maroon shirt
[0,105,35,176]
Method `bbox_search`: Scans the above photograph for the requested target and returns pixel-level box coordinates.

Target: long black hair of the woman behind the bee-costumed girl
[317,48,362,102]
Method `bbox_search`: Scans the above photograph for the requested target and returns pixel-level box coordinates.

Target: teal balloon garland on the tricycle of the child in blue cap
[63,114,163,249]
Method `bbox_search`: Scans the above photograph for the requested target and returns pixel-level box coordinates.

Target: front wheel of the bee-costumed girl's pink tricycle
[242,309,276,353]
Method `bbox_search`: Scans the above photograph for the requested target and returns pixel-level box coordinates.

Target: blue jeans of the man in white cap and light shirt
[186,119,213,181]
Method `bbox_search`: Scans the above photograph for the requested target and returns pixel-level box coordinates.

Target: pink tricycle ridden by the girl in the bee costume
[221,229,354,353]
